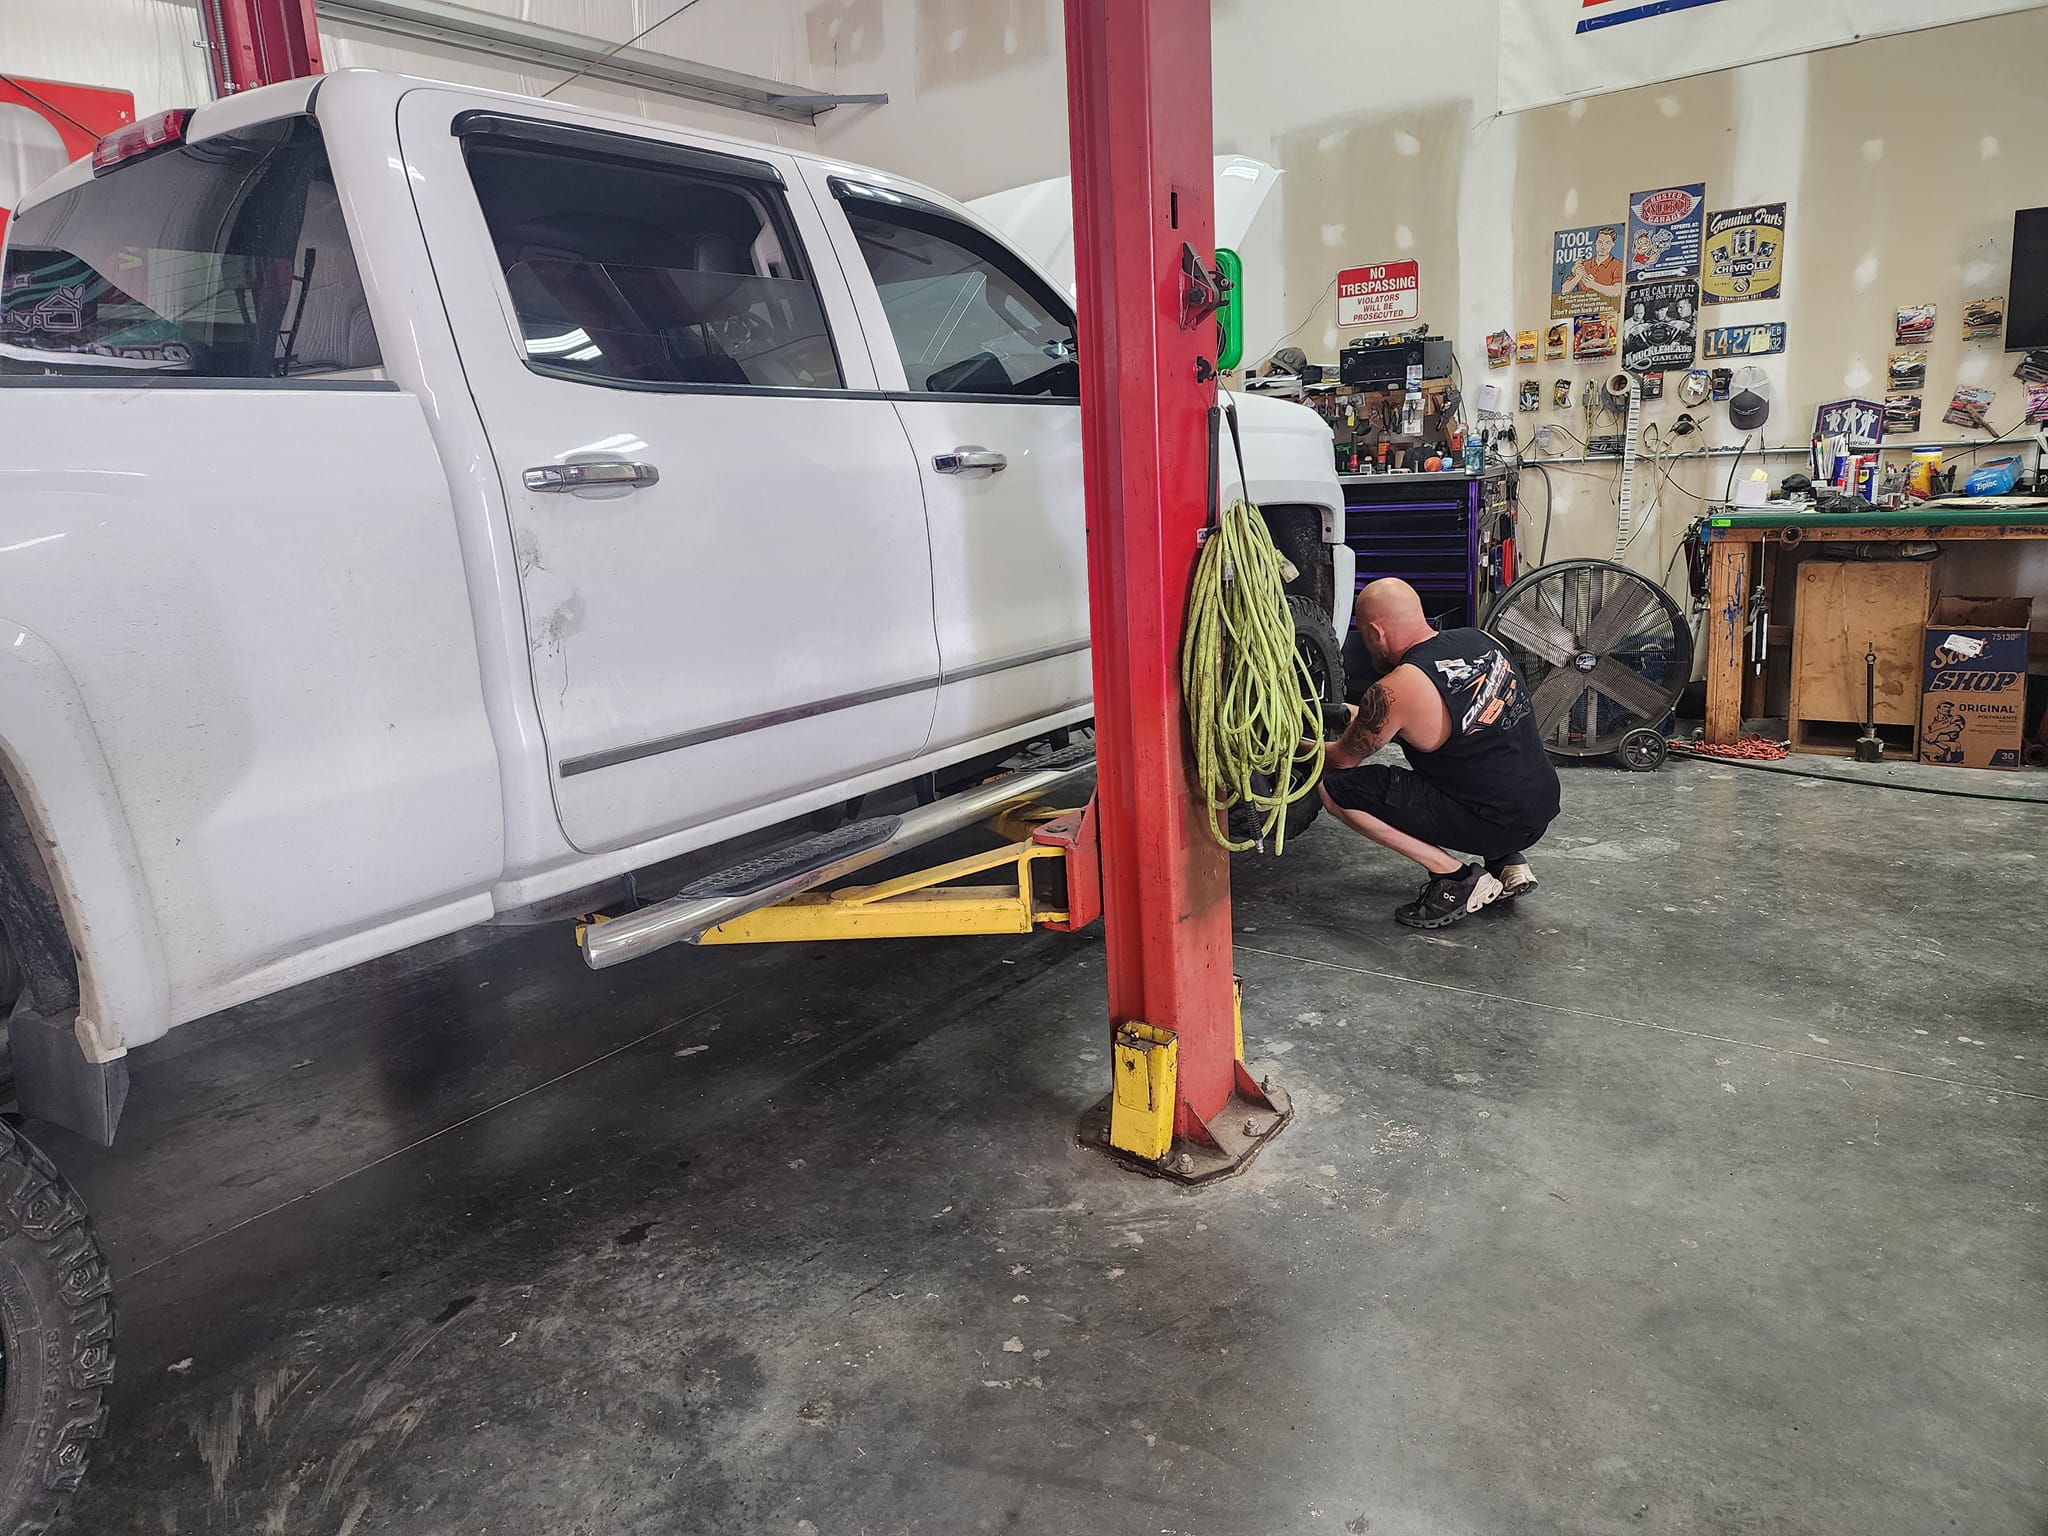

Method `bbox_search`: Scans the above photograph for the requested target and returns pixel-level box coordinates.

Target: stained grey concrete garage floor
[39,764,2048,1536]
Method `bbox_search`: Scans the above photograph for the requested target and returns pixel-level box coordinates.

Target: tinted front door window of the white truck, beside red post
[844,201,1081,399]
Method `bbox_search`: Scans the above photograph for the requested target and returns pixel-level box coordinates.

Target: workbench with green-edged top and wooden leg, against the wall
[1702,496,2048,743]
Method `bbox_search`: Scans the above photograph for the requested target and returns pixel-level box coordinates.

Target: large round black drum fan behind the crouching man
[1485,559,1692,772]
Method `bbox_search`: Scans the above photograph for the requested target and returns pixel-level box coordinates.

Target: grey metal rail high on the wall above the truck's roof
[317,0,889,123]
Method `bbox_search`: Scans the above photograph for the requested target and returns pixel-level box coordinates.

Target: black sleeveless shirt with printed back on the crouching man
[1401,629,1559,831]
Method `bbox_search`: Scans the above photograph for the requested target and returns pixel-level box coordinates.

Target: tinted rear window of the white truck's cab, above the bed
[0,117,381,379]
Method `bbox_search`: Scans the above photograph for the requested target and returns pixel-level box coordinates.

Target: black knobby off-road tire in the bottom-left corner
[0,1120,115,1536]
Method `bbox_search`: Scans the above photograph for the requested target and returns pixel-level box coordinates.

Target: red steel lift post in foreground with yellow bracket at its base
[1067,0,1286,1178]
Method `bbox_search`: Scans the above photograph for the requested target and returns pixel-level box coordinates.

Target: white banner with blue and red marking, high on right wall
[1501,0,2048,113]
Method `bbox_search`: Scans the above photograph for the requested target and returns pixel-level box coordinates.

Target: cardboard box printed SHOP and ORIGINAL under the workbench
[1921,598,2034,768]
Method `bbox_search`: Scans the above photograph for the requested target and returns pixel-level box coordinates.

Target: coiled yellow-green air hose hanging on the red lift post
[1180,500,1323,854]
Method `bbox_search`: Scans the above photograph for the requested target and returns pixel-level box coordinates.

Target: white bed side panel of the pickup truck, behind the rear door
[0,379,502,1055]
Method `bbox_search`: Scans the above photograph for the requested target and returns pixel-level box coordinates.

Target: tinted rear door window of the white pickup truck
[465,139,842,389]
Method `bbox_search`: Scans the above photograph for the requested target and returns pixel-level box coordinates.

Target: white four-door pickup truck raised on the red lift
[0,72,1352,1528]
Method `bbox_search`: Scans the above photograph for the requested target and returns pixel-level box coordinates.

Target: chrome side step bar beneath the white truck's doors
[584,748,1096,971]
